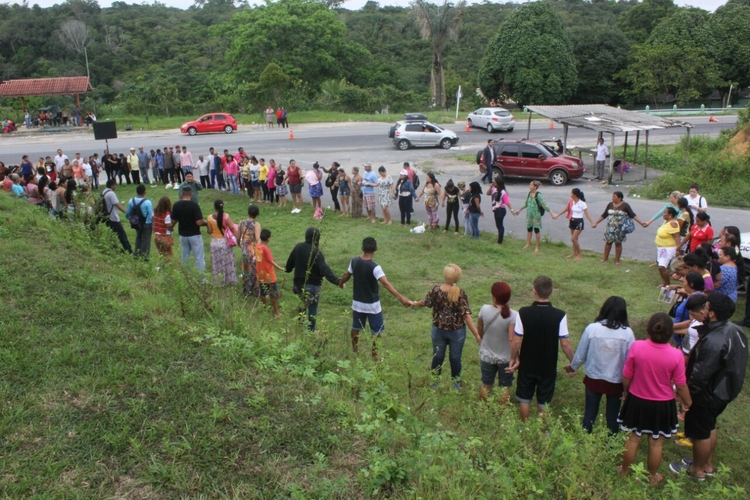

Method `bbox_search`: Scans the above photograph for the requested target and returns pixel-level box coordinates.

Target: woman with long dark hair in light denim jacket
[565,296,635,434]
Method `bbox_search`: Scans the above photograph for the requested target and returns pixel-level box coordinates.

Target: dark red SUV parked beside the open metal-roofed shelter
[484,139,586,186]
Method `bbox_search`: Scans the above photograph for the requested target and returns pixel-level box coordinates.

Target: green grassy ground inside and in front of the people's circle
[0,187,750,499]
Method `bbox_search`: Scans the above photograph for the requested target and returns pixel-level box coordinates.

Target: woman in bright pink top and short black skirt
[617,313,692,486]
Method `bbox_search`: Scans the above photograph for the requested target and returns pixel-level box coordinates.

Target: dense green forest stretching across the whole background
[0,0,750,114]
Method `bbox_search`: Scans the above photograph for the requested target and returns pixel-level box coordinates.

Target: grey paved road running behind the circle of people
[0,113,750,260]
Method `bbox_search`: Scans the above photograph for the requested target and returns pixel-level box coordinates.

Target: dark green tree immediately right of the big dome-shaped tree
[570,25,629,104]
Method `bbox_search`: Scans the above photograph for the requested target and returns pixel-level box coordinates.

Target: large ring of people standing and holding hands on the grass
[0,146,747,485]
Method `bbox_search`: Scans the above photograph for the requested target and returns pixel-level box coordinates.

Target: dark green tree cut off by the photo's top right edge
[708,0,750,92]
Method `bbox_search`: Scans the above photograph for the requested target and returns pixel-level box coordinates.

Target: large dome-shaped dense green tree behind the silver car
[478,2,578,105]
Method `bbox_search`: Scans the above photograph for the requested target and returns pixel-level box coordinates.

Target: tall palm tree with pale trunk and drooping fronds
[411,0,466,109]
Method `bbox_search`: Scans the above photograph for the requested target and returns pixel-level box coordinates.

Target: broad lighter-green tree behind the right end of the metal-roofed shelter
[620,9,721,104]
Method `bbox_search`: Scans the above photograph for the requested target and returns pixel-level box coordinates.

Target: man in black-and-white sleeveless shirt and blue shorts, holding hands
[340,237,411,361]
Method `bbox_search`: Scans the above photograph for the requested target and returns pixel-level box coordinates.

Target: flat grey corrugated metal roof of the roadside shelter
[526,104,693,134]
